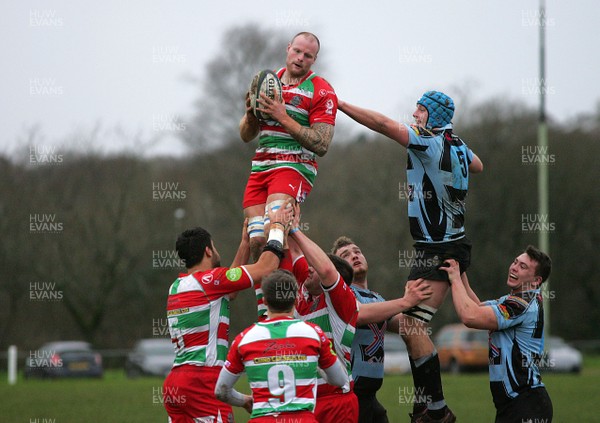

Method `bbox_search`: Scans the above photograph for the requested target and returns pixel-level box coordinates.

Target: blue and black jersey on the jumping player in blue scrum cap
[405,125,473,243]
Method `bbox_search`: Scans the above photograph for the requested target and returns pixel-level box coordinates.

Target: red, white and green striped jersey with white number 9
[225,317,337,418]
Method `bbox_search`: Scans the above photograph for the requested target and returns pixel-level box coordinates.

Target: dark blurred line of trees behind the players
[0,96,600,349]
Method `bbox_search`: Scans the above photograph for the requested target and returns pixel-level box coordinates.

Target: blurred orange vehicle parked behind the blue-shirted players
[434,323,489,373]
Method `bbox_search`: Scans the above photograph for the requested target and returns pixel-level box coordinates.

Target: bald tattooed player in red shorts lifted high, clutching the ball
[240,32,337,261]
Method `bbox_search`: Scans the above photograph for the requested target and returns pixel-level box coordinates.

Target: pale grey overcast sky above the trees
[0,0,600,154]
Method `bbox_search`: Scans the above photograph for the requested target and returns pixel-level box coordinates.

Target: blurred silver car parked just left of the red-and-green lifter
[125,338,175,378]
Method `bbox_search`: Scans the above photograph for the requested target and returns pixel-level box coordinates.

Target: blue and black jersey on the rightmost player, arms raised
[484,289,544,409]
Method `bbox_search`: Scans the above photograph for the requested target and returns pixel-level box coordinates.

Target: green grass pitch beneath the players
[0,357,600,423]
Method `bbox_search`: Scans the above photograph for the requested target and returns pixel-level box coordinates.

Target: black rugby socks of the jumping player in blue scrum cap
[411,351,446,419]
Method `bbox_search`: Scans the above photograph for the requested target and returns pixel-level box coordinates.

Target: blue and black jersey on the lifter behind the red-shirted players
[350,285,387,394]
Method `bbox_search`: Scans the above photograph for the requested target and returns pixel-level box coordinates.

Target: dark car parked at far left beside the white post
[24,341,104,378]
